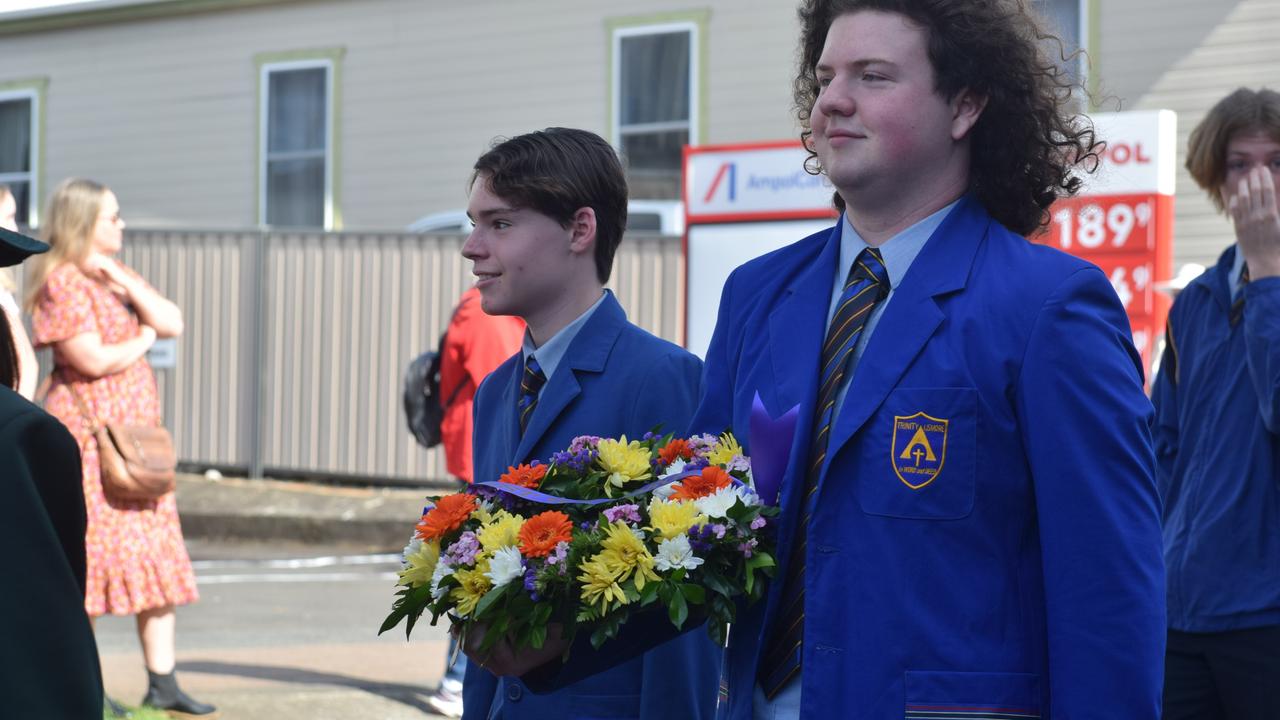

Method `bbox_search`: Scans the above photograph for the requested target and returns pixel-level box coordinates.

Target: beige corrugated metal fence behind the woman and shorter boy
[24,231,685,482]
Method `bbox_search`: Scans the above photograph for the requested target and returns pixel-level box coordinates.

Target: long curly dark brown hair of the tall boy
[792,0,1102,234]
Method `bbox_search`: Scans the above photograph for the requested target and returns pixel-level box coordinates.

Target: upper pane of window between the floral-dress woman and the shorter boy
[266,68,328,152]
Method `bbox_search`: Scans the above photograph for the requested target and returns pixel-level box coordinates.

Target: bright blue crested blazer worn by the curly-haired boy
[692,197,1165,720]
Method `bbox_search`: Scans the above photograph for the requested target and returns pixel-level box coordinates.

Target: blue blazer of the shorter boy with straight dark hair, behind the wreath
[463,293,721,720]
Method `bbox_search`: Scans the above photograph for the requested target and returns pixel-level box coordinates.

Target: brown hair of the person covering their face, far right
[1187,87,1280,210]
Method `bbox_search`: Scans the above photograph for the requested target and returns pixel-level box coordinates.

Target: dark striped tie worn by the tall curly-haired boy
[756,247,888,700]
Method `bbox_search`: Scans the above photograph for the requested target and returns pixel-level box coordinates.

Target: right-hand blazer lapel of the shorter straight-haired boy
[511,291,627,462]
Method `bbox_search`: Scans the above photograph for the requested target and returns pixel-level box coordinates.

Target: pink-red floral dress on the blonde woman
[32,263,198,618]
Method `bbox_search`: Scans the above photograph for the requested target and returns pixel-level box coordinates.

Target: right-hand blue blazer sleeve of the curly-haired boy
[1016,268,1166,720]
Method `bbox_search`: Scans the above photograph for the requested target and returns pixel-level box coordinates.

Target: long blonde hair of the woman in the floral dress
[26,178,108,311]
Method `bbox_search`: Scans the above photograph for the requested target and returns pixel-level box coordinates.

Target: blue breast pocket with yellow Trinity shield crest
[854,388,978,520]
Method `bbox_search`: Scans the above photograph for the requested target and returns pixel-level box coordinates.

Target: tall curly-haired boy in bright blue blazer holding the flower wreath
[471,0,1165,720]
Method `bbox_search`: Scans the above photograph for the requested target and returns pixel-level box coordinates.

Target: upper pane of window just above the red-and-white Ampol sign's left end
[618,31,690,126]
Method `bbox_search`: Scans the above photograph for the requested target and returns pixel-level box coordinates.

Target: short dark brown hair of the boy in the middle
[471,128,627,284]
